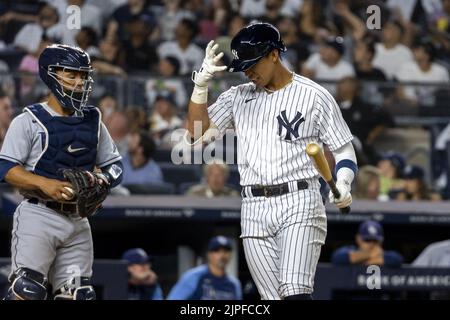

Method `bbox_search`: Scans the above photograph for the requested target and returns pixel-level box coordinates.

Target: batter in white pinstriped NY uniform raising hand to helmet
[188,23,357,300]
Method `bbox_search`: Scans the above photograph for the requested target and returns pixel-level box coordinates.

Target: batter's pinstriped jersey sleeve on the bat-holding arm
[315,89,353,151]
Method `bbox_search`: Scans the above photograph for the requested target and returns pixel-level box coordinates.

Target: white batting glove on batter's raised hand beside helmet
[192,40,227,87]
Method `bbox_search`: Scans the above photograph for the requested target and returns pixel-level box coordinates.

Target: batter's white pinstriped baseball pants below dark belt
[241,182,327,300]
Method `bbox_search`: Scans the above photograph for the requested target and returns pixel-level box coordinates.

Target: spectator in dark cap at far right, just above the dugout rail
[396,165,441,201]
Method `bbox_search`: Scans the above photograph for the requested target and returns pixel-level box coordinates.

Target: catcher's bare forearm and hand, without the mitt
[0,164,72,201]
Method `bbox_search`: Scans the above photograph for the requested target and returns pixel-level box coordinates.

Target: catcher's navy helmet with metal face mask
[39,44,94,111]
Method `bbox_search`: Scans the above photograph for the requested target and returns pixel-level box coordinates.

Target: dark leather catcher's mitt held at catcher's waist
[63,168,109,218]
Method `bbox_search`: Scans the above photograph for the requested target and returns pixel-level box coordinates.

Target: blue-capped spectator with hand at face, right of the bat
[377,152,405,201]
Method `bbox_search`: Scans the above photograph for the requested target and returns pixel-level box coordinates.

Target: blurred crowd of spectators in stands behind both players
[0,0,450,201]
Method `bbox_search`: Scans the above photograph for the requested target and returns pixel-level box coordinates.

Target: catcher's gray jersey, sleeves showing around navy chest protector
[0,103,121,171]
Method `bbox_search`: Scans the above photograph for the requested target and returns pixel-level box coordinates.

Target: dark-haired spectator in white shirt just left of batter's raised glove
[158,19,204,75]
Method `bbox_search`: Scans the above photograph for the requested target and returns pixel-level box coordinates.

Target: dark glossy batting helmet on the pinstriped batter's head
[228,22,286,72]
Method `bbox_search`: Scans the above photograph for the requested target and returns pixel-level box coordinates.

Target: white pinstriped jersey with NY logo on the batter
[208,74,353,186]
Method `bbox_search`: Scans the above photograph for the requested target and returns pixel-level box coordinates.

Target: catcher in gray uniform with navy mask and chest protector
[0,45,122,300]
